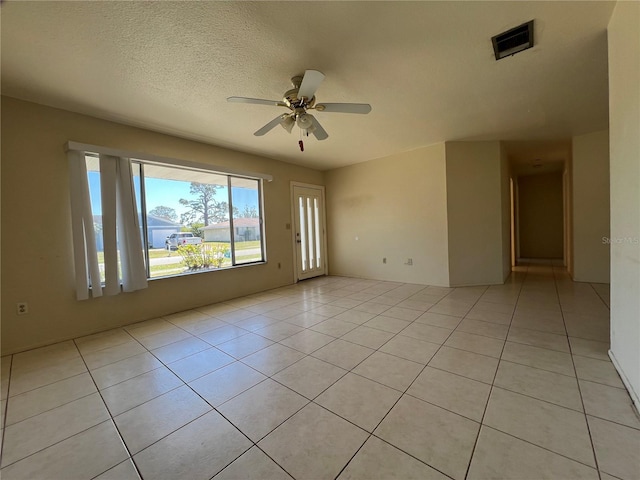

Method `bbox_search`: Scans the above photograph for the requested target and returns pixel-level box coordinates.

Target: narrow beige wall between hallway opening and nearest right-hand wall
[572,130,610,283]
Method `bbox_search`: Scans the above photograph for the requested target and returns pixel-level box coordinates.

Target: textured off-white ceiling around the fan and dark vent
[1,1,614,170]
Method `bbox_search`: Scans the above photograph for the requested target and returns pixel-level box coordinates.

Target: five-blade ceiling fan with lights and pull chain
[227,70,371,144]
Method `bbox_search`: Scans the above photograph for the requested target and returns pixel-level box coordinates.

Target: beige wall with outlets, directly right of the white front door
[326,144,449,285]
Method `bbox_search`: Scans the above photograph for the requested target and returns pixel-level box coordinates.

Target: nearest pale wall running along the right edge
[608,2,640,410]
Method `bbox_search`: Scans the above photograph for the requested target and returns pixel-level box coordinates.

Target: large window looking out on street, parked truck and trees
[85,153,265,282]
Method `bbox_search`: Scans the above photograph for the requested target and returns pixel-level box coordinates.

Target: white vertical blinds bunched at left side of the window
[68,150,147,300]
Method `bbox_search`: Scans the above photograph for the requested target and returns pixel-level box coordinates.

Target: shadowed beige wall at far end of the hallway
[518,172,564,258]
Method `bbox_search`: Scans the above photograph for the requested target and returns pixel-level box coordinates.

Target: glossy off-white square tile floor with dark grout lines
[0,265,640,480]
